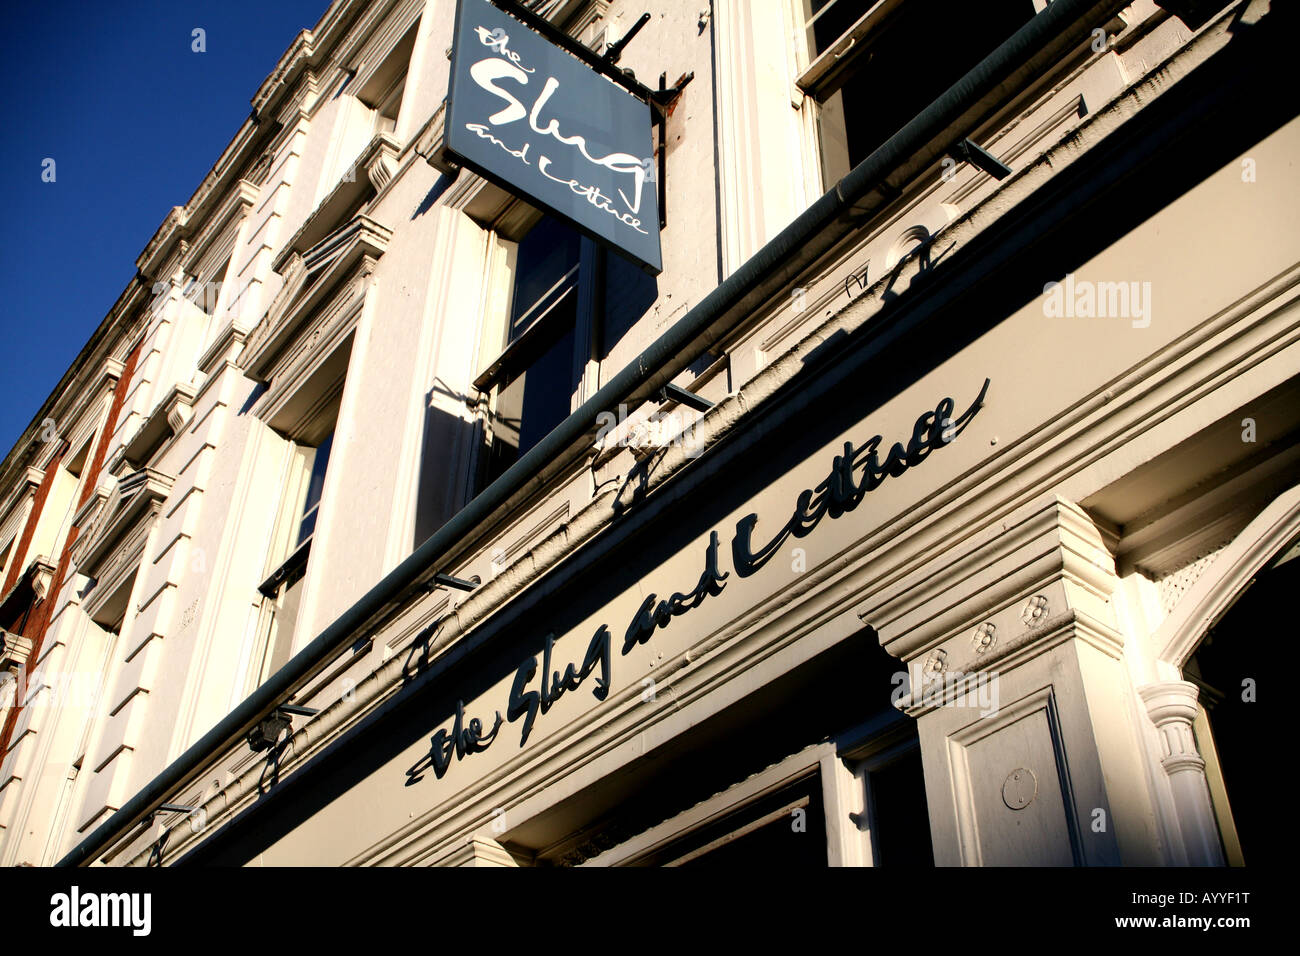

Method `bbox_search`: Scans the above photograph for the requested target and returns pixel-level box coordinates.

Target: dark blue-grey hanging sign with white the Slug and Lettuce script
[446,0,663,274]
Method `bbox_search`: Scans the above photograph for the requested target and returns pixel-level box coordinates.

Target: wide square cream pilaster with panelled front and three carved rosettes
[859,497,1167,866]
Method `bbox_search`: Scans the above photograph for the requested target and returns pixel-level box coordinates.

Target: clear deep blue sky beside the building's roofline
[0,0,329,458]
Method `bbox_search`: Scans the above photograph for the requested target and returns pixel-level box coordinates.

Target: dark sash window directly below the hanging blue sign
[475,216,658,484]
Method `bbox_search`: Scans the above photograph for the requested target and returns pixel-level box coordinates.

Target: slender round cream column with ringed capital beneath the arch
[1138,680,1225,866]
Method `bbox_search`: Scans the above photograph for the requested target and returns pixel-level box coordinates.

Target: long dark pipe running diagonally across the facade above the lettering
[59,0,1128,866]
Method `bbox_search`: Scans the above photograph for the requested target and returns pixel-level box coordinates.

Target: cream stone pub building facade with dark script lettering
[0,0,1300,866]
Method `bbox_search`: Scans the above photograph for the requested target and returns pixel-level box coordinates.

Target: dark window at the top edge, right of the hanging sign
[797,0,1035,186]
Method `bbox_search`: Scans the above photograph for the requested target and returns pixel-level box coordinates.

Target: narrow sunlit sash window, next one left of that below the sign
[250,416,338,689]
